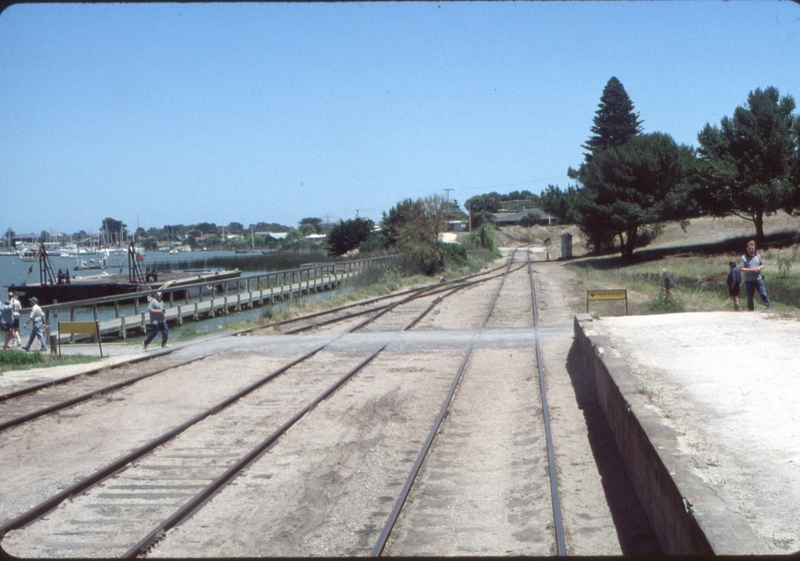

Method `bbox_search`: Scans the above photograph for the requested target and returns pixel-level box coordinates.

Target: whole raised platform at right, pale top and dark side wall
[575,312,800,555]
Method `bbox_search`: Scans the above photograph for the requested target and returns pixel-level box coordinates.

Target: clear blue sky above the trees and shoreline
[0,1,800,233]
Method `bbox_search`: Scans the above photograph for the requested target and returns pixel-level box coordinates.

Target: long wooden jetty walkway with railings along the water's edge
[30,254,400,343]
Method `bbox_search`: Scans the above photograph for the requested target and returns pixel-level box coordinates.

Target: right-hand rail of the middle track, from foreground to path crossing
[122,342,389,558]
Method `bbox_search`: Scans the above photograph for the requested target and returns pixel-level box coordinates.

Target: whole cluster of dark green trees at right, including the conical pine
[539,77,800,259]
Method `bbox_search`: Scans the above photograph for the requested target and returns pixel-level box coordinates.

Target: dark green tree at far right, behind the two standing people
[697,87,800,239]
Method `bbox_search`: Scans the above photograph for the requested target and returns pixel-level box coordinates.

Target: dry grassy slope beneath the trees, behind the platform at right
[567,215,800,318]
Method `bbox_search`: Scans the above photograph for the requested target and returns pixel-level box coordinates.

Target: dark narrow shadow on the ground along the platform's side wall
[567,343,664,555]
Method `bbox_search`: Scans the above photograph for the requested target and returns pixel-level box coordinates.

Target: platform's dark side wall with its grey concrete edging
[574,314,766,555]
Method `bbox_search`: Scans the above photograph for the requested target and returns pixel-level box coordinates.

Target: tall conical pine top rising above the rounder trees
[583,76,642,162]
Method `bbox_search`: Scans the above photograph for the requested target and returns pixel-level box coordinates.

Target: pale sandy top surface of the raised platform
[591,312,800,554]
